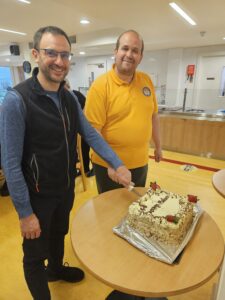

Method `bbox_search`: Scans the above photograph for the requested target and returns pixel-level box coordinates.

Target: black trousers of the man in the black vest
[23,186,74,300]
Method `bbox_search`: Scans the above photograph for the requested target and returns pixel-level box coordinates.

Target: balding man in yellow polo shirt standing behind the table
[85,30,162,193]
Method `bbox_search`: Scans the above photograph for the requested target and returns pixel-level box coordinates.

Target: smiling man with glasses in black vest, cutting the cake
[0,26,131,300]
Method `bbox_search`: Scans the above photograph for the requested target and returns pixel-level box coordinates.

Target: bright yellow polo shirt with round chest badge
[85,69,158,169]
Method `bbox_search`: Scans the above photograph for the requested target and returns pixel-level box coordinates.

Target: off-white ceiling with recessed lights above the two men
[0,0,225,55]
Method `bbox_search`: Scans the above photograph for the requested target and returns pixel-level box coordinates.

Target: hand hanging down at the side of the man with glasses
[20,214,41,239]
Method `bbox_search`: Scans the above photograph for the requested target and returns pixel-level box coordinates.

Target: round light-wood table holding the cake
[71,188,224,297]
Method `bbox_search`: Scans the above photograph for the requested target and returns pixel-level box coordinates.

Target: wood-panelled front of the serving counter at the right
[159,110,225,159]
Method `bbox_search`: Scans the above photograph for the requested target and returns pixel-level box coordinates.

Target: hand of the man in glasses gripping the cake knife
[108,166,131,188]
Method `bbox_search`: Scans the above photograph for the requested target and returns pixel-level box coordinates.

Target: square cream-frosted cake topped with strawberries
[127,183,198,245]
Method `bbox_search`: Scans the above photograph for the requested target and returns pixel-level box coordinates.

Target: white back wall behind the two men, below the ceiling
[0,45,225,109]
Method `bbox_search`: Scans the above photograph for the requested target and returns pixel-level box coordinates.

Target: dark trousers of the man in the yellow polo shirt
[93,164,148,194]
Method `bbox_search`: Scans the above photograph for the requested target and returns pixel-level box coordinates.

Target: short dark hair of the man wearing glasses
[33,26,71,49]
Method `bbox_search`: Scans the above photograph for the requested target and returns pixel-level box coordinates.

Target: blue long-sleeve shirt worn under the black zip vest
[0,90,122,218]
